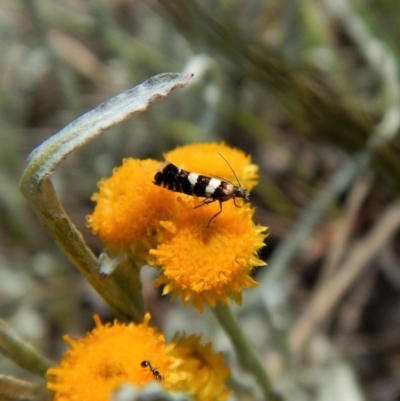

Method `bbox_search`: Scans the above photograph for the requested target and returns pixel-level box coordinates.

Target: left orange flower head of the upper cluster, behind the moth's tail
[86,159,176,251]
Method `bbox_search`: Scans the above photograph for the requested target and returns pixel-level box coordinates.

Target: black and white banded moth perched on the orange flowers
[153,155,250,227]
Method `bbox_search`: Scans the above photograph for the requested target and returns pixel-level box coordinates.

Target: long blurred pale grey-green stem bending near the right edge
[251,0,400,366]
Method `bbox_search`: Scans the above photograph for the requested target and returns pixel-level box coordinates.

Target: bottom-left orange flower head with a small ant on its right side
[47,314,173,401]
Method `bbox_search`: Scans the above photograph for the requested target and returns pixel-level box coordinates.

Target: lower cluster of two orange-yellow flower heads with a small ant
[47,314,229,401]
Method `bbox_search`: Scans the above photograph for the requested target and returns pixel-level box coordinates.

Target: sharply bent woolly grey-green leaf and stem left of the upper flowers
[20,73,192,322]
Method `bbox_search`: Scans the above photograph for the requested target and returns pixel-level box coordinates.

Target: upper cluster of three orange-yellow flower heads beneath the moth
[87,143,266,311]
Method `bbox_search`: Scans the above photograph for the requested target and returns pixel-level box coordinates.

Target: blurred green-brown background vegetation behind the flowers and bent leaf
[0,0,400,401]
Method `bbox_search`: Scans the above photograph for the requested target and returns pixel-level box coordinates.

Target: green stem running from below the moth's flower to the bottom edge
[211,302,282,401]
